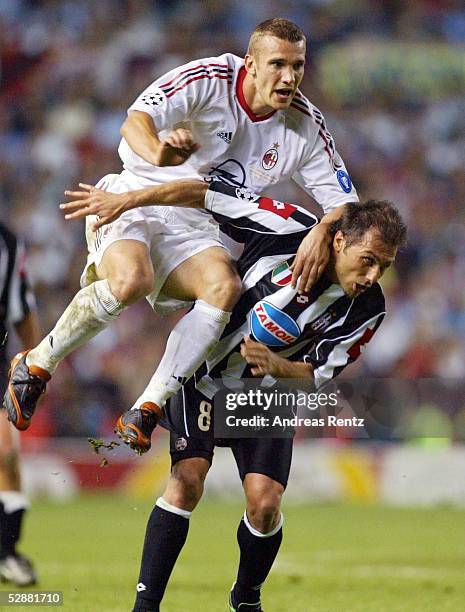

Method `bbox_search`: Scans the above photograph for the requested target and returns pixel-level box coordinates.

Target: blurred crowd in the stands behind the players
[0,0,465,439]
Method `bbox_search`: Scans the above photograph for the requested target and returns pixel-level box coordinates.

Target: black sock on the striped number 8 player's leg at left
[133,506,189,612]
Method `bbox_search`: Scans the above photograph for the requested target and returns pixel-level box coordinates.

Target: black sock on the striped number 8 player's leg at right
[234,519,283,603]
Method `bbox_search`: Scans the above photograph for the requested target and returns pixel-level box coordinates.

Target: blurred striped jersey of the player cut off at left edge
[0,223,35,367]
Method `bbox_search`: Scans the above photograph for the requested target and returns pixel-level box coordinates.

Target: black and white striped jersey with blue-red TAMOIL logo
[196,182,385,390]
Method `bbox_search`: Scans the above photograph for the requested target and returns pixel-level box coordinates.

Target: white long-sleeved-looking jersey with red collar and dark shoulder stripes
[119,53,358,215]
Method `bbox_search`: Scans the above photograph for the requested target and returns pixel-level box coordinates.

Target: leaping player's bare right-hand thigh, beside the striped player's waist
[163,247,241,307]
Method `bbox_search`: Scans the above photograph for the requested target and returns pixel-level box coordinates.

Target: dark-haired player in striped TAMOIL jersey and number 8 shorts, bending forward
[59,182,406,612]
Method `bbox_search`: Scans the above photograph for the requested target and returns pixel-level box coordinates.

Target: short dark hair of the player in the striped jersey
[331,200,407,248]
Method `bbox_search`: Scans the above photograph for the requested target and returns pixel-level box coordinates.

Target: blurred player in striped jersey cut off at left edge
[0,223,40,586]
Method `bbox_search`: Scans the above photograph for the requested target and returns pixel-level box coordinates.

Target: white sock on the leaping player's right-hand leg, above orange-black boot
[132,300,231,410]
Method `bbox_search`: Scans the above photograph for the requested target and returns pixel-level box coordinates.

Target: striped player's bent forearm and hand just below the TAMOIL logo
[241,336,313,379]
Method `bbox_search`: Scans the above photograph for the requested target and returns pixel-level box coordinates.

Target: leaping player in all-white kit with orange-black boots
[4,19,358,447]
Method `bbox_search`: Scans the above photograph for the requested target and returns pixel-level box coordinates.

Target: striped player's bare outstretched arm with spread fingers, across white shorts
[60,181,208,231]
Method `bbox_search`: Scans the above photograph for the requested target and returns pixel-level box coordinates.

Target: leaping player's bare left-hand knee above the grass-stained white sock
[97,239,154,302]
